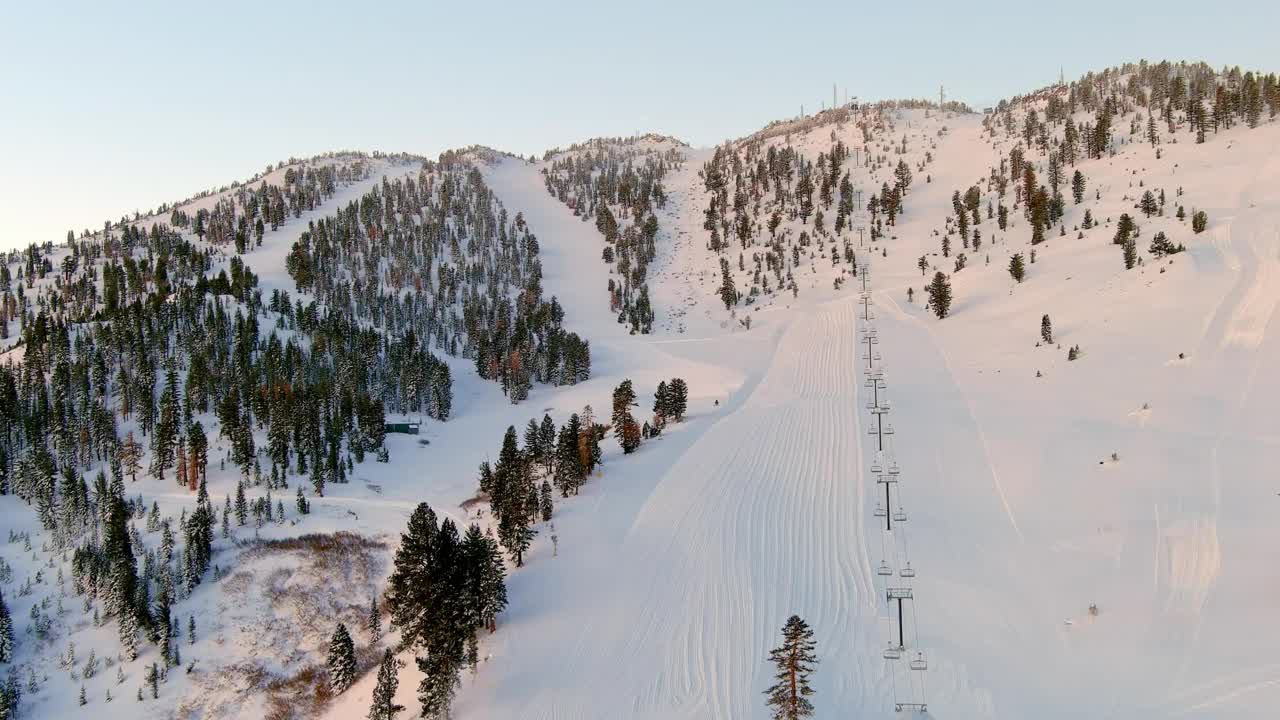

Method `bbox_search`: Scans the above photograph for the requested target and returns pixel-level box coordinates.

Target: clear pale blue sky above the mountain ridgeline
[0,0,1280,247]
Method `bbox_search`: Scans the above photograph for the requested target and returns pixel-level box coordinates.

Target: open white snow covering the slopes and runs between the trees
[0,96,1280,720]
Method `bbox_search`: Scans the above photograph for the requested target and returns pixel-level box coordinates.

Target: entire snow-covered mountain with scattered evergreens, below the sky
[0,63,1280,719]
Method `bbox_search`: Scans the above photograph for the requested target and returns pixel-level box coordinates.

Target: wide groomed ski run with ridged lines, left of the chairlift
[458,289,901,717]
